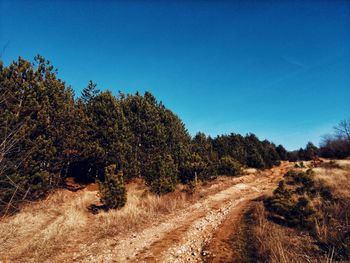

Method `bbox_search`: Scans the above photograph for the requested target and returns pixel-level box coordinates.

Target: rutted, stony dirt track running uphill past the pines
[66,163,288,262]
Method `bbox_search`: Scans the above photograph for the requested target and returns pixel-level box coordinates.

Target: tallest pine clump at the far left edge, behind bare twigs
[0,56,74,214]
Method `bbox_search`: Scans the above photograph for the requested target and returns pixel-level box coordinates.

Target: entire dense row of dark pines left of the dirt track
[0,56,286,212]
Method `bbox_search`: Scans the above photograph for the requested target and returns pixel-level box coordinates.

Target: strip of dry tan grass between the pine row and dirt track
[0,175,241,262]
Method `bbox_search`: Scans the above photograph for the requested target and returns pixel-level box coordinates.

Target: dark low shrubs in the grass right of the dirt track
[264,168,350,262]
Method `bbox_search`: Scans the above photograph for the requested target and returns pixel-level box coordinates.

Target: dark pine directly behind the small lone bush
[82,91,131,180]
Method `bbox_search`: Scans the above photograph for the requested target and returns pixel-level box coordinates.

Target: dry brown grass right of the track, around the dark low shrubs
[246,160,350,263]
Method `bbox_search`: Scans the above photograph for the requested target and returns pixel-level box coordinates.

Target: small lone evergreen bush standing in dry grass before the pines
[99,164,126,209]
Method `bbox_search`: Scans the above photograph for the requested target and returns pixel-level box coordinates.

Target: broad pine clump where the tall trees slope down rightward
[121,92,191,183]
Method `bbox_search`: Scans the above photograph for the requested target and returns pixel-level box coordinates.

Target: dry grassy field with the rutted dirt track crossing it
[0,161,350,262]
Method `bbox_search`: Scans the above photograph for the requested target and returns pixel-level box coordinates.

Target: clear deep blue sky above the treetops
[0,0,350,149]
